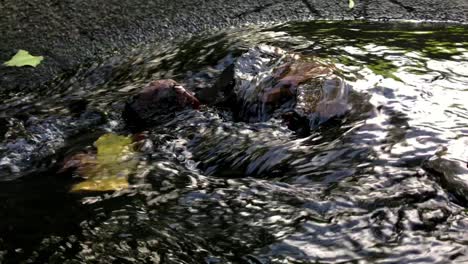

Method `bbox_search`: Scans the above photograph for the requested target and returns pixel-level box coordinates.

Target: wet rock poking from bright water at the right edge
[423,138,468,203]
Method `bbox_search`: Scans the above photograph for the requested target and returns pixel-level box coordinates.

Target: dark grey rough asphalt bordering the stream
[0,0,468,92]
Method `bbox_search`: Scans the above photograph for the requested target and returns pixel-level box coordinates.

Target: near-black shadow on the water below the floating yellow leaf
[0,174,86,263]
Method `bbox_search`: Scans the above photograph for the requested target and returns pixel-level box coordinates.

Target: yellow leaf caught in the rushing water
[70,134,137,192]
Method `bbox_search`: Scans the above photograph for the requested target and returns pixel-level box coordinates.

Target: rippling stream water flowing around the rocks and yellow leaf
[0,22,468,263]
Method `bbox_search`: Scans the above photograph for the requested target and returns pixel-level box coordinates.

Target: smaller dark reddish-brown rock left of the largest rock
[122,79,200,127]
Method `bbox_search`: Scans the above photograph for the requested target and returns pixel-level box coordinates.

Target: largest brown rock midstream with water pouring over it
[233,45,350,133]
